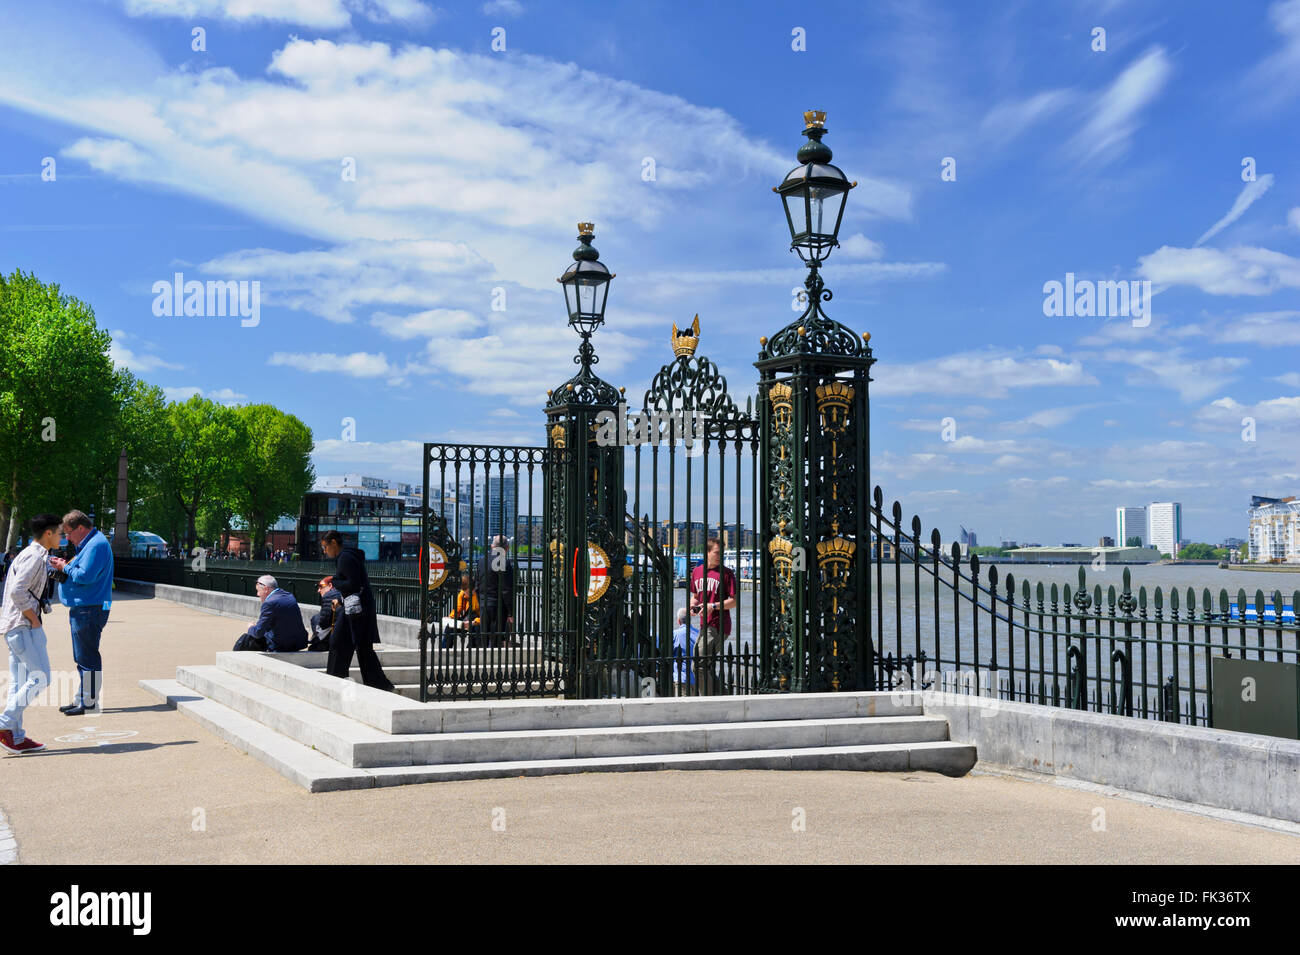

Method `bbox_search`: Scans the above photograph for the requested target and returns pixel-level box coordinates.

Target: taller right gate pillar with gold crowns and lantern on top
[754,110,875,691]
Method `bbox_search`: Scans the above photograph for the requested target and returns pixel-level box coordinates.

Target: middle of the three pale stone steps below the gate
[177,667,948,768]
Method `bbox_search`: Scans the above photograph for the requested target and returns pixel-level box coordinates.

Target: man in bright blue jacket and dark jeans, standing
[49,511,113,716]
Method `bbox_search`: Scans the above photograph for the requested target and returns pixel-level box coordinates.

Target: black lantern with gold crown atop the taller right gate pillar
[772,109,858,262]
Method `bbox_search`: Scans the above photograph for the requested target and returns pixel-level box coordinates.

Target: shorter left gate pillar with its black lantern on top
[545,222,627,696]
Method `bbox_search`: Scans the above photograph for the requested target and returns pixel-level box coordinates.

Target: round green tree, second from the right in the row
[157,395,247,554]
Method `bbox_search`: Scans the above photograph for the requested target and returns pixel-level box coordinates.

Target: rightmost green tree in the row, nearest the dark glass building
[231,404,316,554]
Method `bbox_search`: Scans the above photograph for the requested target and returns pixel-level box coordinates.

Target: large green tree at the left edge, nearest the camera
[0,270,121,544]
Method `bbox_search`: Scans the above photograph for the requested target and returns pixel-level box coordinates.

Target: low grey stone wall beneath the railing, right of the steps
[925,691,1300,822]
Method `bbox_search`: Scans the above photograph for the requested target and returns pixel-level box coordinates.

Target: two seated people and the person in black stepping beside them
[234,530,395,691]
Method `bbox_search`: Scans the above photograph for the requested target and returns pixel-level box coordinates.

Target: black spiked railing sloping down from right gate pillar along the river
[868,487,1300,726]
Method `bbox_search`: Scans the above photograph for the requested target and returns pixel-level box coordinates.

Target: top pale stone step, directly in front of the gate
[216,651,922,733]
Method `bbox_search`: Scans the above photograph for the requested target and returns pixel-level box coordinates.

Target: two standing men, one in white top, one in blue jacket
[0,511,113,756]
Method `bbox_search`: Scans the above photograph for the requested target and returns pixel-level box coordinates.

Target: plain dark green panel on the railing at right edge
[1210,656,1300,739]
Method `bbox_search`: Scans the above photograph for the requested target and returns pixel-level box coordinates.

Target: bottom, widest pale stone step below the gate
[140,680,975,793]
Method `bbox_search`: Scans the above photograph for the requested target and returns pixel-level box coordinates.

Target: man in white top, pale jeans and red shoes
[0,515,62,756]
